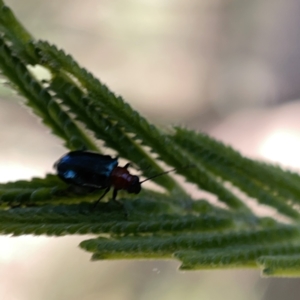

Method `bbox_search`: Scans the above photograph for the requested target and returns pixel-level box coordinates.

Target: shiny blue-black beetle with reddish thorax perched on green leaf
[54,150,173,207]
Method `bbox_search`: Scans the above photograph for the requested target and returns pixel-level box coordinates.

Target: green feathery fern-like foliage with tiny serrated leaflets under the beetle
[0,0,300,276]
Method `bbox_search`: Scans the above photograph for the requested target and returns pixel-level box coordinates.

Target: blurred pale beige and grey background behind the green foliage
[0,0,300,300]
